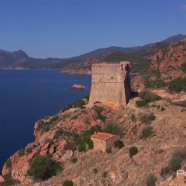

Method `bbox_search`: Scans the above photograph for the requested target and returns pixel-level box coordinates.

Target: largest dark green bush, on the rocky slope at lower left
[27,154,61,180]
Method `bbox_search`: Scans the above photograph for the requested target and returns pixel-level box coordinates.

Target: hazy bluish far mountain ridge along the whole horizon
[0,34,186,69]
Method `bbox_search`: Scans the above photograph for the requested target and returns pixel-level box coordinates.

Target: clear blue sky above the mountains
[0,0,186,58]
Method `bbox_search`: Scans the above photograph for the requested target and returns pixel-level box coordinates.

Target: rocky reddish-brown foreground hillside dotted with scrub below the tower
[2,93,186,186]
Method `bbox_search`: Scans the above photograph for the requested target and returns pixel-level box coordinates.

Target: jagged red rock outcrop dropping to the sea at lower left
[0,104,102,183]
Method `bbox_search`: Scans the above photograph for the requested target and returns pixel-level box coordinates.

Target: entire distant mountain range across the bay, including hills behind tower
[0,34,186,73]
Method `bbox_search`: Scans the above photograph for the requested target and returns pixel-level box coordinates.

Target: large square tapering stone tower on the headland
[88,61,131,107]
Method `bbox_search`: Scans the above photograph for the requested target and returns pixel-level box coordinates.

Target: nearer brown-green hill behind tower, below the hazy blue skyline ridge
[62,42,170,74]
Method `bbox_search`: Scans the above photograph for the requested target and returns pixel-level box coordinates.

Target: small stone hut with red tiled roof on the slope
[91,132,119,152]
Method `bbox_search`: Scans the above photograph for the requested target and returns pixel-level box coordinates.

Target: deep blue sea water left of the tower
[0,70,91,170]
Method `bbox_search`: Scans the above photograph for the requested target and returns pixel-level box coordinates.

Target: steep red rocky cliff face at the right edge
[151,39,186,82]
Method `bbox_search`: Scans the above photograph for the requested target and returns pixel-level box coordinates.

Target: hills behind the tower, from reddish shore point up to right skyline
[62,34,186,74]
